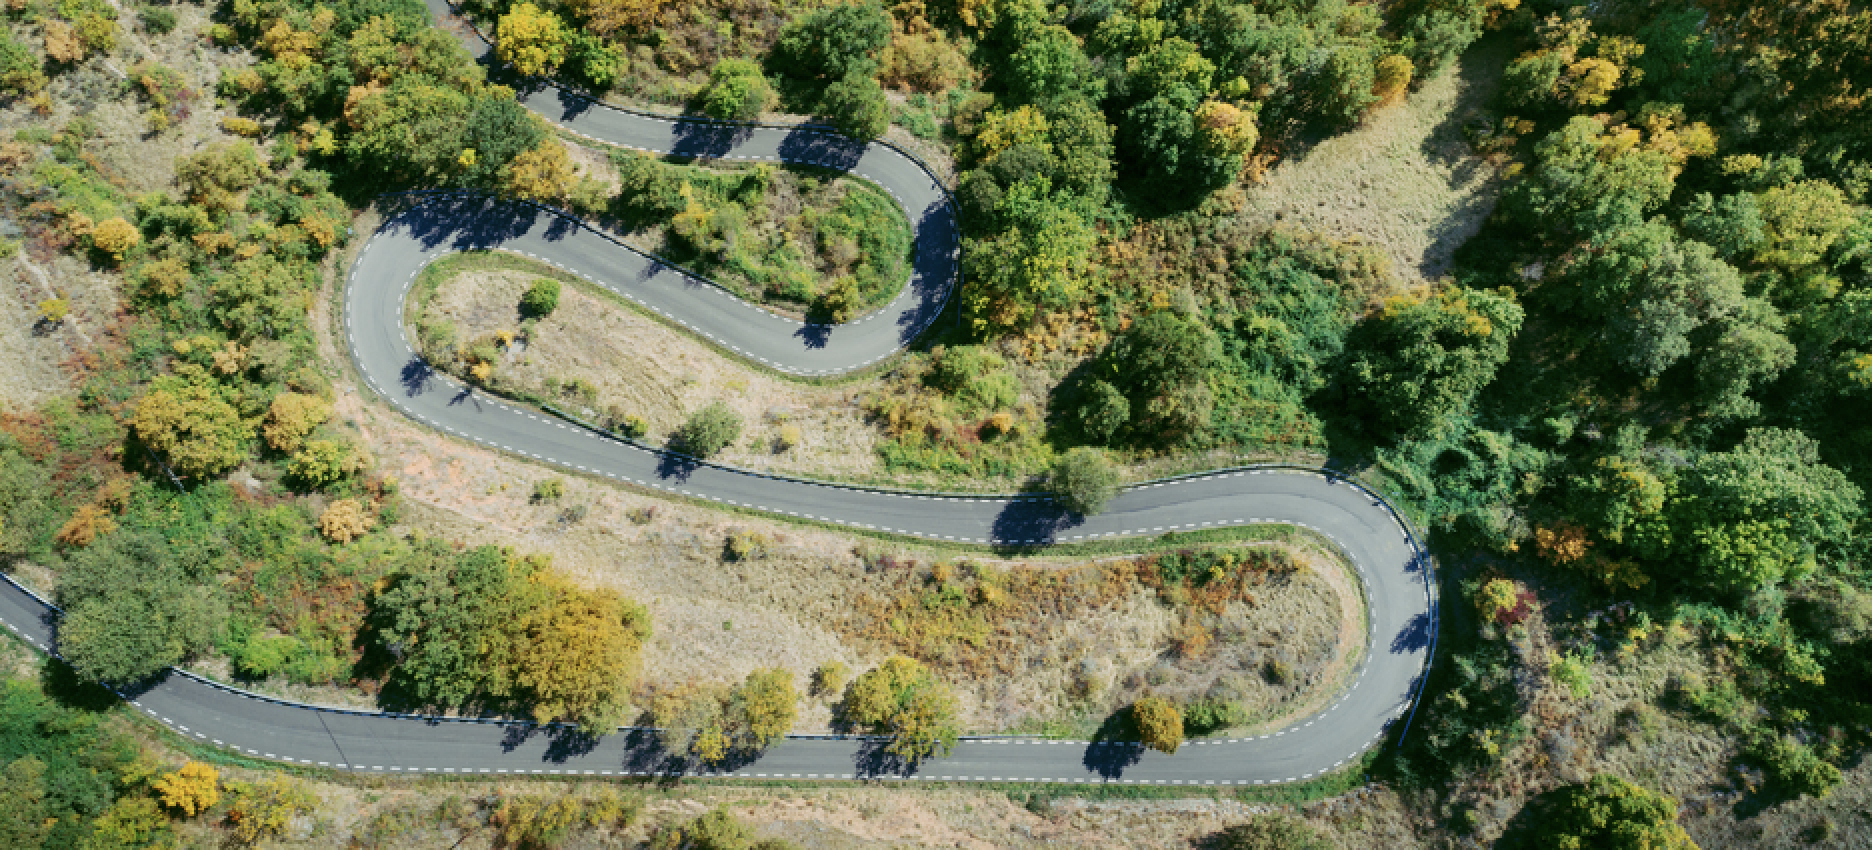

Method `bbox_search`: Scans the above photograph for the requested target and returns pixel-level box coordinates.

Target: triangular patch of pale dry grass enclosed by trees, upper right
[1243,41,1507,279]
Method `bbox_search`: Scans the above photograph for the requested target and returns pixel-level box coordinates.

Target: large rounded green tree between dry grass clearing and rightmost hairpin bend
[1340,288,1524,436]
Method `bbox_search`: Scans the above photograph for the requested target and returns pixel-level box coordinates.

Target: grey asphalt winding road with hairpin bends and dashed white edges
[0,0,1436,784]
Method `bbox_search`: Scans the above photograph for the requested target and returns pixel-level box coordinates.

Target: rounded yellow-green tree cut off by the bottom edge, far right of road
[1543,775,1696,850]
